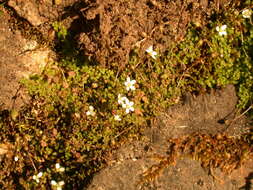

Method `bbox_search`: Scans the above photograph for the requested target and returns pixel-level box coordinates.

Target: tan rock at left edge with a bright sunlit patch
[0,7,53,109]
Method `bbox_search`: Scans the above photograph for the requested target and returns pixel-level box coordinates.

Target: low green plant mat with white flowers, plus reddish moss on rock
[0,1,253,189]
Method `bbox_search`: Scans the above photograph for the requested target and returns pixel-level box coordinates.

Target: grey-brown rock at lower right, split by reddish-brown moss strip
[88,85,253,190]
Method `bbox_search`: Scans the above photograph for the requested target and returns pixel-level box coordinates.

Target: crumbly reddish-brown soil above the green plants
[76,0,239,69]
